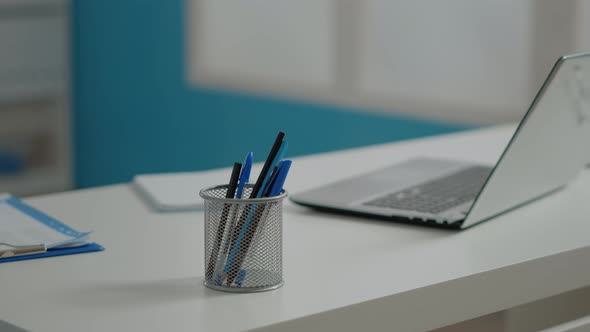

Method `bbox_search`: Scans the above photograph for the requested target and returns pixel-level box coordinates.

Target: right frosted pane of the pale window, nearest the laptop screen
[360,0,534,123]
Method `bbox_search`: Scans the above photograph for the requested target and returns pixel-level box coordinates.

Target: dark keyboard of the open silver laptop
[364,166,491,214]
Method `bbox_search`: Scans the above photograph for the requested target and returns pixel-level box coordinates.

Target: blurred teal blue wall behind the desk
[73,0,468,187]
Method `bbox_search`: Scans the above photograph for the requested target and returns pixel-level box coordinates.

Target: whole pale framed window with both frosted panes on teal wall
[187,0,590,123]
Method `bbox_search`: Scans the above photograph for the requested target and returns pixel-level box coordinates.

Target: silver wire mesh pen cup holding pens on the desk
[199,185,287,293]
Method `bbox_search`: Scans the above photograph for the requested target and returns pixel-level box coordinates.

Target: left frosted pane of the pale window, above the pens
[188,0,335,91]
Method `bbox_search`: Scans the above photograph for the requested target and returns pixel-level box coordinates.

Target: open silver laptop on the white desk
[291,53,590,229]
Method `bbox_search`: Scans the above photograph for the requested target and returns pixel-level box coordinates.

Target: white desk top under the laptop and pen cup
[0,126,590,332]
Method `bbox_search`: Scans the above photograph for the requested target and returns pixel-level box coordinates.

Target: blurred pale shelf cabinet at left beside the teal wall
[0,0,72,195]
